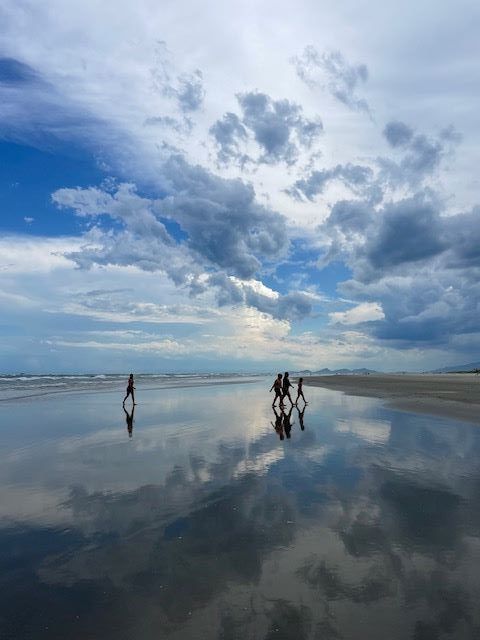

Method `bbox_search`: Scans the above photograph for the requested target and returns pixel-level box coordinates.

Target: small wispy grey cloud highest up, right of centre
[292,45,370,113]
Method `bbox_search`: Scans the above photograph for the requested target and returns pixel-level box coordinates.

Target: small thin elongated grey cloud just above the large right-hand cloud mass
[286,163,373,201]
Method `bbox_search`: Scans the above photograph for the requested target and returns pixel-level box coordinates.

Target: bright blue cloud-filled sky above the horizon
[0,0,480,373]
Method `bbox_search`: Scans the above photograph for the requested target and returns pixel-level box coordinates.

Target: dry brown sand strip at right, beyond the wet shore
[304,373,480,424]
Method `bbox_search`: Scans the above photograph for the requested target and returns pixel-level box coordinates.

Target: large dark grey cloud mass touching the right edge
[321,192,480,349]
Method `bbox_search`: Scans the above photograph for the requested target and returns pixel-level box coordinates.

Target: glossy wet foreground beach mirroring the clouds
[0,379,480,640]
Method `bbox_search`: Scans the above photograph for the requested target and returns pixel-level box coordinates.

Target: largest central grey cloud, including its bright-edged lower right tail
[52,166,312,319]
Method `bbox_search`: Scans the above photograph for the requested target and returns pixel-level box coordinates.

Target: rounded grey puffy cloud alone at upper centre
[210,91,323,165]
